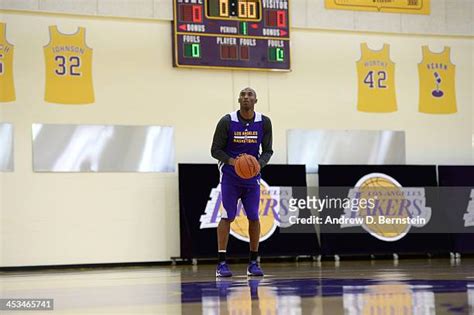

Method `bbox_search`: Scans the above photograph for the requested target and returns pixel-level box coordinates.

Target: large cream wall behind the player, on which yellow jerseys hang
[0,11,474,266]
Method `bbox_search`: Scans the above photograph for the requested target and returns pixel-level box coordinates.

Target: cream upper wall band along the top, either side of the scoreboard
[0,0,474,35]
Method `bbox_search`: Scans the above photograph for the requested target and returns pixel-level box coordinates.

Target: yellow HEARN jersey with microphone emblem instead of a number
[418,46,457,114]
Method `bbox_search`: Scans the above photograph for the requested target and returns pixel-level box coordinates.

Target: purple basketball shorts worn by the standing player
[221,184,260,221]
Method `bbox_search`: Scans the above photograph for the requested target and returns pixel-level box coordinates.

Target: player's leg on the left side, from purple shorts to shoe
[216,185,240,277]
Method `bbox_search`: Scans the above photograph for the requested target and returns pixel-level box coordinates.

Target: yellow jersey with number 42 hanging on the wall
[357,43,397,113]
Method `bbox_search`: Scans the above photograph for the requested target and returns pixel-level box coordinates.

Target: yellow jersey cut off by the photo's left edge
[0,23,16,102]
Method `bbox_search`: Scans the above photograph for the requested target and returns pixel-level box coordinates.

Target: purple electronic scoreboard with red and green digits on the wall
[173,0,290,71]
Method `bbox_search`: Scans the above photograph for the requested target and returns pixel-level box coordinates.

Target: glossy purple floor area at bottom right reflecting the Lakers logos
[181,278,474,315]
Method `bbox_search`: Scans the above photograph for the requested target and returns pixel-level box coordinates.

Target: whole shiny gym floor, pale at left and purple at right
[0,259,474,315]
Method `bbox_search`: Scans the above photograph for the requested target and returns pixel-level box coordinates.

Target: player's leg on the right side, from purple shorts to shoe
[241,186,263,276]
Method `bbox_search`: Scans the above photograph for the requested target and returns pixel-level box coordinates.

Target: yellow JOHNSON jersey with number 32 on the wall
[44,25,94,104]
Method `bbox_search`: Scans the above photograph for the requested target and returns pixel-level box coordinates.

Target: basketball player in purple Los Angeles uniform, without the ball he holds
[211,88,273,277]
